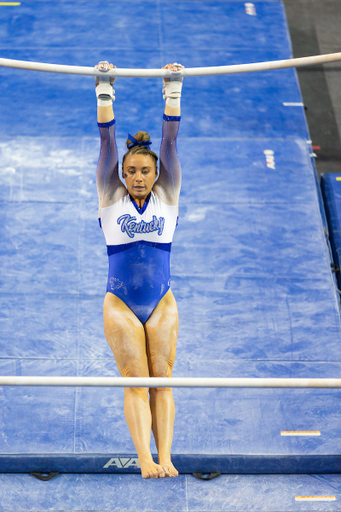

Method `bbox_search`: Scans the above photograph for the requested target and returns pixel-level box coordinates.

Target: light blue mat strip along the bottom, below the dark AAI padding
[0,474,341,512]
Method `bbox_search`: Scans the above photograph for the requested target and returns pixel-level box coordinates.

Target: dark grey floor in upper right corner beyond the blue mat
[283,0,341,175]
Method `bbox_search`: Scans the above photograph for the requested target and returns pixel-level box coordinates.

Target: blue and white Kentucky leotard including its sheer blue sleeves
[97,116,181,324]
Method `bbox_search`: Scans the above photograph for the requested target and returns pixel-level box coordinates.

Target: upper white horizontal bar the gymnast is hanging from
[0,52,341,77]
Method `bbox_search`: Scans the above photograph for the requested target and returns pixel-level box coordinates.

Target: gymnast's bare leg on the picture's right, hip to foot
[144,290,179,477]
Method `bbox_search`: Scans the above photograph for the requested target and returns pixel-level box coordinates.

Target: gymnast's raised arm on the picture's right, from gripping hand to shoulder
[154,64,183,205]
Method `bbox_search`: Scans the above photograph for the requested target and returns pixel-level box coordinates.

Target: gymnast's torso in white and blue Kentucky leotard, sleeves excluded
[101,190,178,323]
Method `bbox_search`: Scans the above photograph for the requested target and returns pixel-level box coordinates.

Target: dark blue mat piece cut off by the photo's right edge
[321,174,341,288]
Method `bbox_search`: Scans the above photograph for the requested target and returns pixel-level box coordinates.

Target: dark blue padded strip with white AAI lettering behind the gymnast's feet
[0,453,341,474]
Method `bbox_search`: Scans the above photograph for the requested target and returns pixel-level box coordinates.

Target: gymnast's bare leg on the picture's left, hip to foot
[103,293,165,478]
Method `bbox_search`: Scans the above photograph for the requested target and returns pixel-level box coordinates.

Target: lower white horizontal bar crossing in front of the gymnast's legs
[0,376,341,388]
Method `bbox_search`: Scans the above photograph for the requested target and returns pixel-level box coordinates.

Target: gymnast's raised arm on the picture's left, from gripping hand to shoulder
[96,62,126,217]
